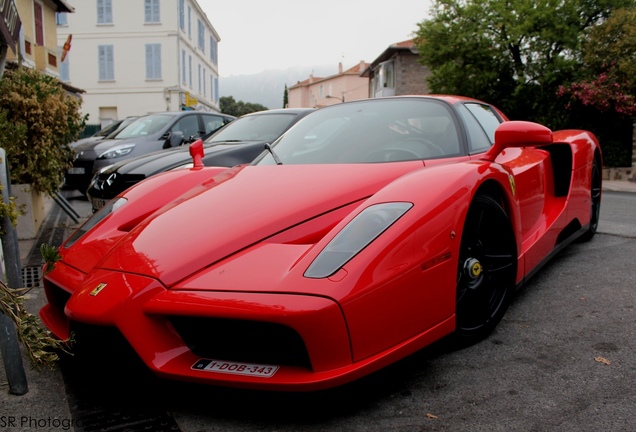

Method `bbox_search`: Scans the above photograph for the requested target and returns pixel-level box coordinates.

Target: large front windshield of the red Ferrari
[254,98,462,165]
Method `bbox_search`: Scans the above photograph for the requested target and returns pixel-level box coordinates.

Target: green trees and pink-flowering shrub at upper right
[416,0,636,166]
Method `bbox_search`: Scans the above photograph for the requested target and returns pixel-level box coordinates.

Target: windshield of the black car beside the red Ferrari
[206,113,296,144]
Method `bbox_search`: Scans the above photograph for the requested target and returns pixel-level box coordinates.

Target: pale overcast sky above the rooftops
[198,0,431,77]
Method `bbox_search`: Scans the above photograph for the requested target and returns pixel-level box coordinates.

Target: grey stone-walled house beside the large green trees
[362,40,430,98]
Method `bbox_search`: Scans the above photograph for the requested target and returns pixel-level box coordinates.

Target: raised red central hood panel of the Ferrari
[97,161,423,286]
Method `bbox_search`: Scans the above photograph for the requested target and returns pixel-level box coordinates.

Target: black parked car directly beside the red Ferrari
[87,108,314,211]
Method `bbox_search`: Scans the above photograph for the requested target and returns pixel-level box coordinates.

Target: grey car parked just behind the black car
[64,111,235,193]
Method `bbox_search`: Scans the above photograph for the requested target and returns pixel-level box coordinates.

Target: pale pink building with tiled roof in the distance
[287,61,369,108]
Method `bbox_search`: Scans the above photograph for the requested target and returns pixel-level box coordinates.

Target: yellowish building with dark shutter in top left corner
[7,0,73,77]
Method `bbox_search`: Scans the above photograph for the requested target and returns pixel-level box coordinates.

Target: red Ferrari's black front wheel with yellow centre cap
[455,195,517,343]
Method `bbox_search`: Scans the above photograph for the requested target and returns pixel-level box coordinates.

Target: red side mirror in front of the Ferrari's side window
[482,121,552,162]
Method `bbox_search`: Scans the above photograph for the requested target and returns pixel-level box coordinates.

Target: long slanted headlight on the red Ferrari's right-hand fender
[305,202,413,279]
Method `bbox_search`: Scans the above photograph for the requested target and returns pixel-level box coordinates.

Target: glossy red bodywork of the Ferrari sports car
[40,97,600,390]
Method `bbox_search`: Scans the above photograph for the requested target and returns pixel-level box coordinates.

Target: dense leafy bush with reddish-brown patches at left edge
[0,67,86,195]
